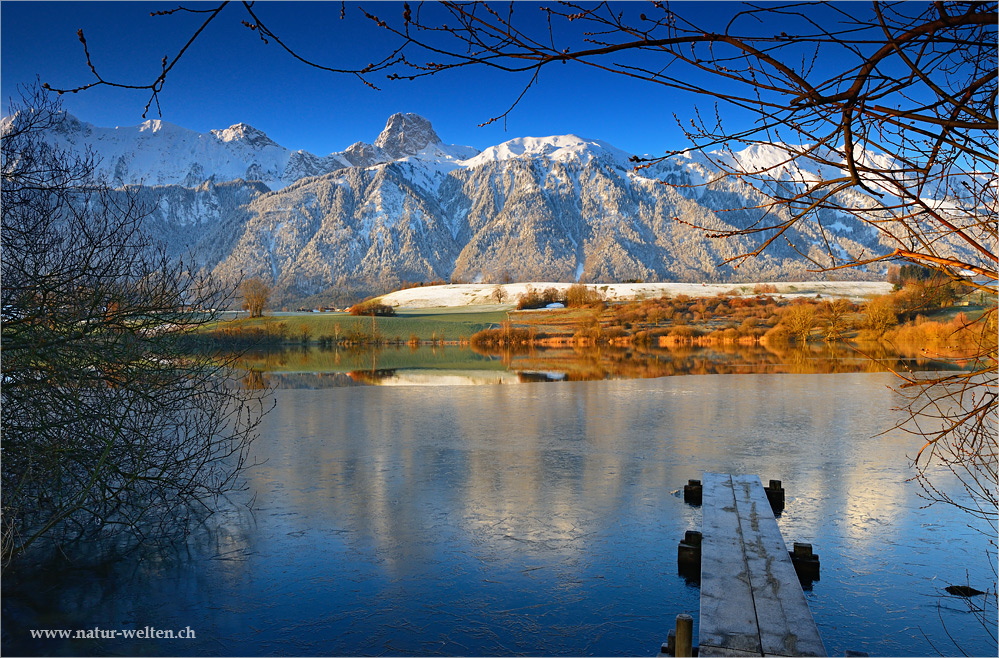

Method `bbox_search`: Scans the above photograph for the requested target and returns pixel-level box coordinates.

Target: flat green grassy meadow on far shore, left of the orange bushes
[205,308,507,341]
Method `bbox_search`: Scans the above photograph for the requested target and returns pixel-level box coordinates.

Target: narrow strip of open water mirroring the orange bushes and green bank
[238,343,966,388]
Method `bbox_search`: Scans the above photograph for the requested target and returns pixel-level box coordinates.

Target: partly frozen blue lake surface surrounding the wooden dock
[2,367,997,656]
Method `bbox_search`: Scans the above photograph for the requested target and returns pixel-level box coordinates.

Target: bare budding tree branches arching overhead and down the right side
[45,1,999,524]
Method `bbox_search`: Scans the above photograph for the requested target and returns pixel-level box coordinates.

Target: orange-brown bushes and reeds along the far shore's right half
[470,281,996,356]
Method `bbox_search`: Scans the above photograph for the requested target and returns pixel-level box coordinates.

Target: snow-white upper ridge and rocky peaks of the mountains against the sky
[21,106,868,190]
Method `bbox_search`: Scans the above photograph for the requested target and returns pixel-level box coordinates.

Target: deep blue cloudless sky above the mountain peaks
[0,0,836,155]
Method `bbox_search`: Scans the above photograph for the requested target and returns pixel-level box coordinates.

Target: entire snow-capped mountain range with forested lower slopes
[15,114,932,300]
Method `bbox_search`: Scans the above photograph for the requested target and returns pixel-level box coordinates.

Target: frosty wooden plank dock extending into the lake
[698,473,826,656]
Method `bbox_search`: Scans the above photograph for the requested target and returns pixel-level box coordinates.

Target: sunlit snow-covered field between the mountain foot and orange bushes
[380,281,892,310]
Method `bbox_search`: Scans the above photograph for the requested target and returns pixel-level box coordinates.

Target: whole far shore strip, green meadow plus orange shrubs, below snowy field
[190,280,996,356]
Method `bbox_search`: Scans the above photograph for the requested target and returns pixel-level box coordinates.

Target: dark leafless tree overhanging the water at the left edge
[0,87,265,566]
